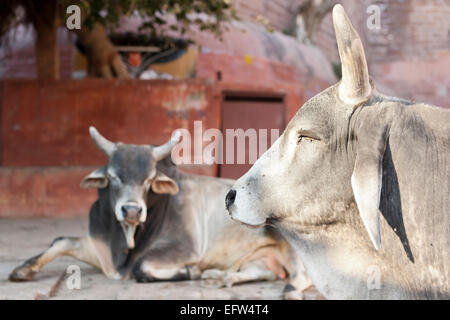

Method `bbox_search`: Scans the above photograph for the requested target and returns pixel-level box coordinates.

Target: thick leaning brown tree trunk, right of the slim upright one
[76,23,131,79]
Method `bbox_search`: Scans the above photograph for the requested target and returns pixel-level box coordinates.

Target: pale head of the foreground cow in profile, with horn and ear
[226,5,386,249]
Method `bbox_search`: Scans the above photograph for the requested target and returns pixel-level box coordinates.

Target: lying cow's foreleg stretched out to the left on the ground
[9,237,117,281]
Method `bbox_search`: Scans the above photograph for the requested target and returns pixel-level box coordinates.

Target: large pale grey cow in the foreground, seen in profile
[226,5,450,299]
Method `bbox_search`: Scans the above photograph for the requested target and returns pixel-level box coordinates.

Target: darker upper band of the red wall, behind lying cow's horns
[0,79,220,169]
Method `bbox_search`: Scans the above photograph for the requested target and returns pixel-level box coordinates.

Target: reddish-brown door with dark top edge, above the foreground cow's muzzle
[219,93,286,179]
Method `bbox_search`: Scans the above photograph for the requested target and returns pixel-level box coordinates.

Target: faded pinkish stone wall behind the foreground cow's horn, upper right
[315,0,450,108]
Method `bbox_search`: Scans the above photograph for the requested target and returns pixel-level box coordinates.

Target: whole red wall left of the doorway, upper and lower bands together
[0,79,221,217]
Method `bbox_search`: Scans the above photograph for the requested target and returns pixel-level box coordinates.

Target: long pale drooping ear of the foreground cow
[351,125,387,250]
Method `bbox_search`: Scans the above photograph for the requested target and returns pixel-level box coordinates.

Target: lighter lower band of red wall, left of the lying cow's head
[0,167,97,218]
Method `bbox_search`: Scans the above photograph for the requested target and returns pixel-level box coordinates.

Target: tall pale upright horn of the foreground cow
[333,4,372,104]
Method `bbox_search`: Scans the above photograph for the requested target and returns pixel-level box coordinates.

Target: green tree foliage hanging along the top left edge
[0,0,237,38]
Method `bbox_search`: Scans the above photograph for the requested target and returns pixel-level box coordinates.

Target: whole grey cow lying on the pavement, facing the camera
[9,127,310,297]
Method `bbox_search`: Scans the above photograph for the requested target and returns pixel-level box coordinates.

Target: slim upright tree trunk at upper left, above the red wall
[33,0,59,79]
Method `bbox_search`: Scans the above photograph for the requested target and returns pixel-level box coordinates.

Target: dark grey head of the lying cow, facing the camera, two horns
[81,127,180,249]
